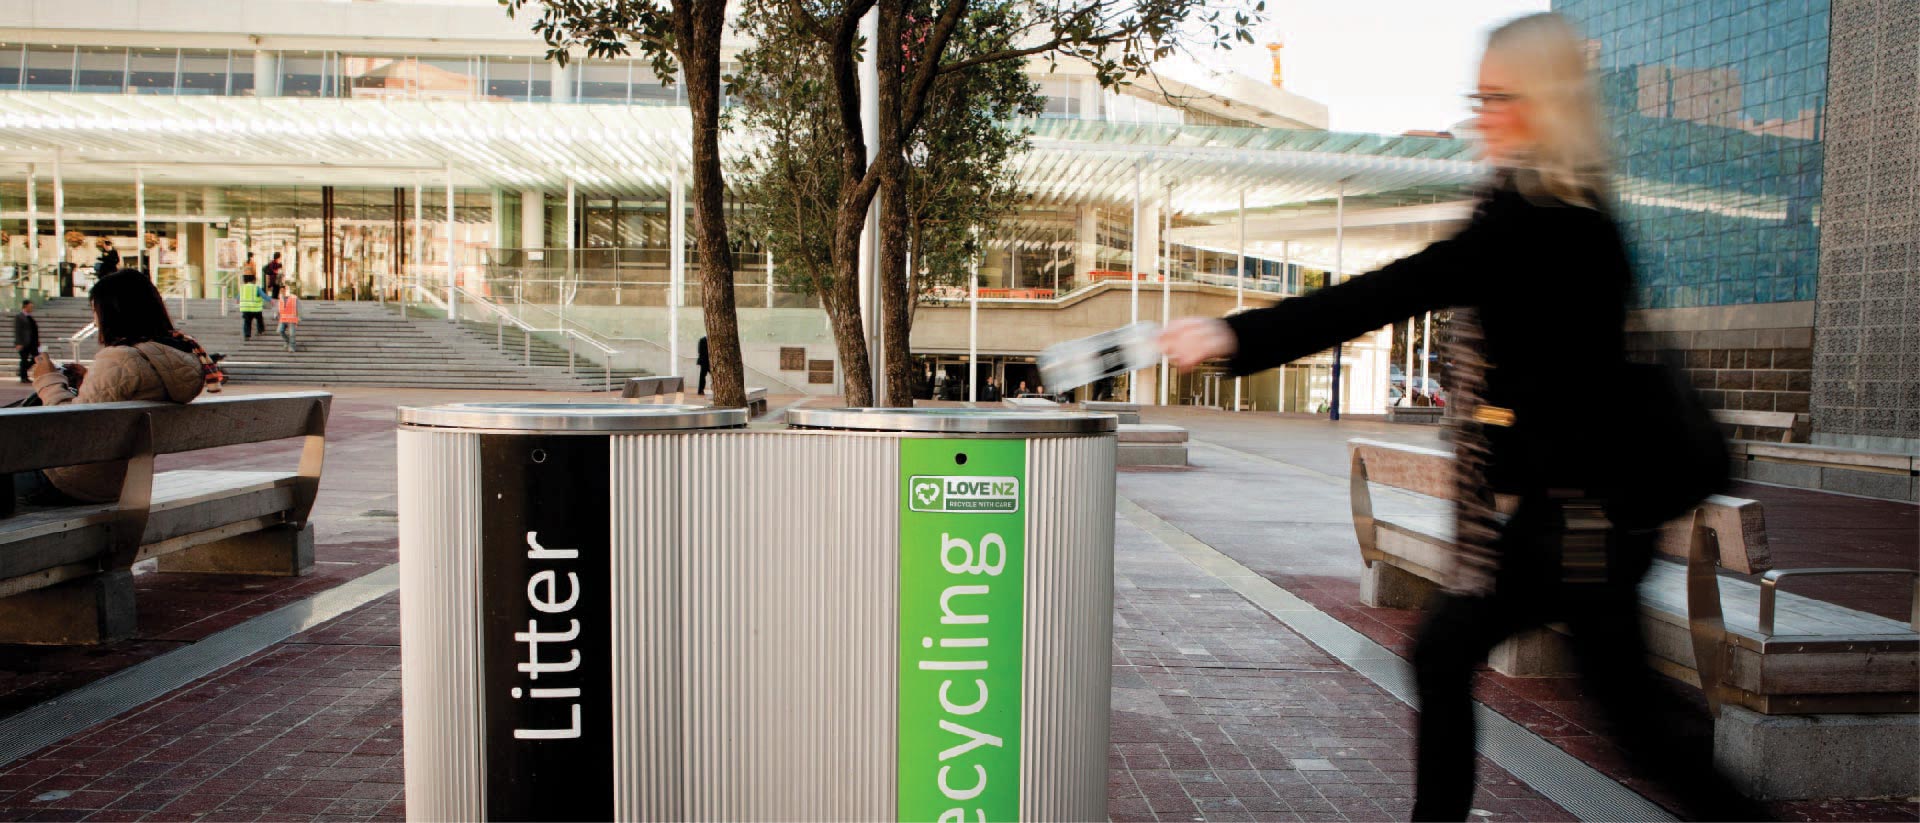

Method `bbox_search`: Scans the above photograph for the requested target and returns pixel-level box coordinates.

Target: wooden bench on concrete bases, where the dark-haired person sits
[0,391,332,645]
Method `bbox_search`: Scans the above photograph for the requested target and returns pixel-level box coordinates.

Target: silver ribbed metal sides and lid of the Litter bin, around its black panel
[399,405,745,821]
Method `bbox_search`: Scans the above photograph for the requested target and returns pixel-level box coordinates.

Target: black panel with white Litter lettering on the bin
[480,435,612,821]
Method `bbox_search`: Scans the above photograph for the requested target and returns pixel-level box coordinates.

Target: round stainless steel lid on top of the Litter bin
[399,403,747,434]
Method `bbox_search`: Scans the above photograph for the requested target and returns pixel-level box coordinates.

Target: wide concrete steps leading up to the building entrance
[22,297,620,391]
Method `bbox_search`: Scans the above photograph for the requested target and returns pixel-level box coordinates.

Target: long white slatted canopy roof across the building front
[0,92,1480,213]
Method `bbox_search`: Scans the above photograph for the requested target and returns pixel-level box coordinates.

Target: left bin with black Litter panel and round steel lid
[399,403,747,821]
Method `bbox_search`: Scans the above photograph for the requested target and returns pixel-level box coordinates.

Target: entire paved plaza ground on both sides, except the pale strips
[0,389,1920,821]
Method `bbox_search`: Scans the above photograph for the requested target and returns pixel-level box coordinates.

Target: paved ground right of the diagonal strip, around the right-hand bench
[1119,409,1920,819]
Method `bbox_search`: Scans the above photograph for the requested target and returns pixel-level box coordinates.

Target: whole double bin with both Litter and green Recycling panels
[399,403,1116,821]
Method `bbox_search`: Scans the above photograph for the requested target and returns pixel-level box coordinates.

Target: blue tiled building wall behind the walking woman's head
[1553,0,1832,309]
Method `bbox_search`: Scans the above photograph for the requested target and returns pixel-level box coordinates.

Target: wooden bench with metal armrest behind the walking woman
[1350,439,1920,798]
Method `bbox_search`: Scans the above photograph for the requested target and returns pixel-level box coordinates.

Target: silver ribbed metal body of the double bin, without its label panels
[399,407,1116,821]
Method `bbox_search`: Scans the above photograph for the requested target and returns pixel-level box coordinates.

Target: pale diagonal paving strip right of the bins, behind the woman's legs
[1117,497,1676,821]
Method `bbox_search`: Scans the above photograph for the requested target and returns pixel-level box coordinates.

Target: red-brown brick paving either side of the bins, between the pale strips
[0,498,1571,821]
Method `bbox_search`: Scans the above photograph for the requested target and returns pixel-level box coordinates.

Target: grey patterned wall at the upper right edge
[1812,0,1920,453]
